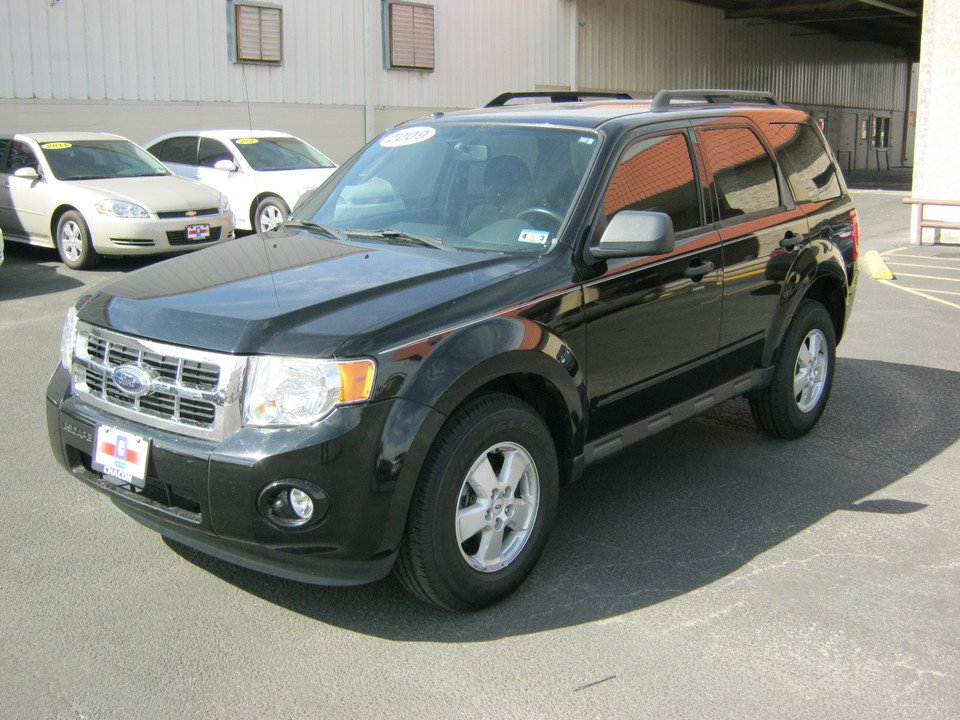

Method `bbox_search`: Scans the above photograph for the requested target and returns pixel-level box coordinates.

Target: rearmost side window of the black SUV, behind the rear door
[768,123,842,203]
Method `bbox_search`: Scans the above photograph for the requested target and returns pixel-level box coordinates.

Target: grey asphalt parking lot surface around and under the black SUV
[0,191,960,720]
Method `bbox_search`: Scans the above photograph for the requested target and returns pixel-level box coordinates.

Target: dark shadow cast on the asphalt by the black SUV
[168,358,960,642]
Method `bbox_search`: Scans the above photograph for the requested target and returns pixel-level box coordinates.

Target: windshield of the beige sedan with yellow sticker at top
[40,140,169,180]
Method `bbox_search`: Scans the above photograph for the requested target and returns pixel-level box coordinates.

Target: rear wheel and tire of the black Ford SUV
[750,300,837,439]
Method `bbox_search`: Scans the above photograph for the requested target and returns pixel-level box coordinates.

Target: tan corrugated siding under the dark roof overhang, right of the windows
[579,0,908,110]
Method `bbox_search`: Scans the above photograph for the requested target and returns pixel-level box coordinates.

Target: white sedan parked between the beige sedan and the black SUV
[146,130,337,232]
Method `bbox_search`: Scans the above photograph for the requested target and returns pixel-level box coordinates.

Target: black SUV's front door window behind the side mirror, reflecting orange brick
[603,133,702,231]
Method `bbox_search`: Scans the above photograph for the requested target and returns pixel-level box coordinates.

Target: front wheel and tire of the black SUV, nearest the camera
[396,394,558,612]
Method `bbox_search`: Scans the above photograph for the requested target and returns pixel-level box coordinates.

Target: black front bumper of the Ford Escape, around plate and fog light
[46,367,436,585]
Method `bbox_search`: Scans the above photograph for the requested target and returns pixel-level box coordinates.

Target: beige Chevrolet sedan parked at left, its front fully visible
[0,132,234,269]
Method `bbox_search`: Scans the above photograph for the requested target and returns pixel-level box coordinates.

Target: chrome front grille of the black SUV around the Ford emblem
[73,323,245,439]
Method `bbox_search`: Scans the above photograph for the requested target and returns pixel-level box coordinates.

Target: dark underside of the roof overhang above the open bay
[690,0,923,61]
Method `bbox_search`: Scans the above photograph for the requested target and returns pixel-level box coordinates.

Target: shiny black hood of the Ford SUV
[80,230,537,357]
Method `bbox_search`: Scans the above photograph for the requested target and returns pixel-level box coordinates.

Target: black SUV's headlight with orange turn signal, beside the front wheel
[243,356,375,427]
